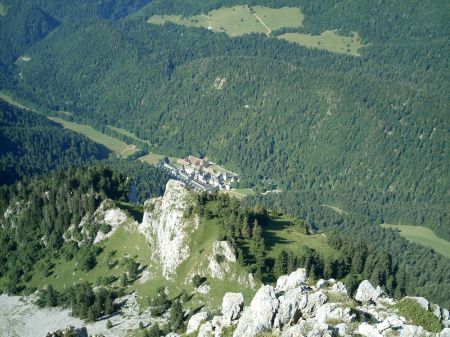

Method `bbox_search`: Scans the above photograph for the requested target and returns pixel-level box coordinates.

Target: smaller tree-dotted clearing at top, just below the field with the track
[278,30,361,56]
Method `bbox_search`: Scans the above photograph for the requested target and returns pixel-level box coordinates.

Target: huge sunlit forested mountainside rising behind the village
[6,1,450,238]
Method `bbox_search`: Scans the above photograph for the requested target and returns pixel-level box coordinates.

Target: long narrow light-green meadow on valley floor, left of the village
[48,117,138,158]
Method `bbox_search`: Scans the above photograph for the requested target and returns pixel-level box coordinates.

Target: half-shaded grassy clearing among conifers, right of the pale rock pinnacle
[263,216,338,257]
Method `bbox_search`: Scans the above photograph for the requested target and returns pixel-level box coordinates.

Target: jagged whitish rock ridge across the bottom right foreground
[183,269,450,337]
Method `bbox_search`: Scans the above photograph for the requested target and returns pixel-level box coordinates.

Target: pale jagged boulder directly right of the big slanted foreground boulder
[274,288,308,328]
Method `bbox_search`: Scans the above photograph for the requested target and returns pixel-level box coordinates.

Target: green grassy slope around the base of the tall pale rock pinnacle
[29,203,254,309]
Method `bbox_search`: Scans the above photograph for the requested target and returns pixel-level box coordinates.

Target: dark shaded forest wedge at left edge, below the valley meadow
[0,100,109,185]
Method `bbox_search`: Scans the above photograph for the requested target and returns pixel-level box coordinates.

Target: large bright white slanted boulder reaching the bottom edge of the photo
[233,285,280,337]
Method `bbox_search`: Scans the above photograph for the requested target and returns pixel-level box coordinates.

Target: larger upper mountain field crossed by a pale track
[147,5,303,37]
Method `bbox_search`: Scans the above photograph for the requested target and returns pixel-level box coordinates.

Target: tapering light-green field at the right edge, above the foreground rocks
[381,224,450,259]
